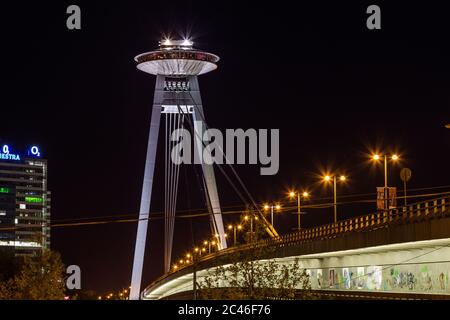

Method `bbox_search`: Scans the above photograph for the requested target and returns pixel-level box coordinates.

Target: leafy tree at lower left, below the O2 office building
[0,250,65,300]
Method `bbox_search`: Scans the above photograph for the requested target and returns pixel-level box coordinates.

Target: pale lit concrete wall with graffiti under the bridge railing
[145,238,450,299]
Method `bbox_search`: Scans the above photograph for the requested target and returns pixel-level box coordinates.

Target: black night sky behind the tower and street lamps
[0,0,450,292]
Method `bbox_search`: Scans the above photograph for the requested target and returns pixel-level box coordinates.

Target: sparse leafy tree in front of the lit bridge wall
[198,246,312,300]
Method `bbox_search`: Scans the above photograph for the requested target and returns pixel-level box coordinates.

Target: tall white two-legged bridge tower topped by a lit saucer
[130,40,227,300]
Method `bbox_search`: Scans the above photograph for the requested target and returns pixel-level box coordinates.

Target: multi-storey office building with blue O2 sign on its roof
[0,144,50,256]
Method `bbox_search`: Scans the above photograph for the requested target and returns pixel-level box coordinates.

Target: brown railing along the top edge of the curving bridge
[173,193,450,270]
